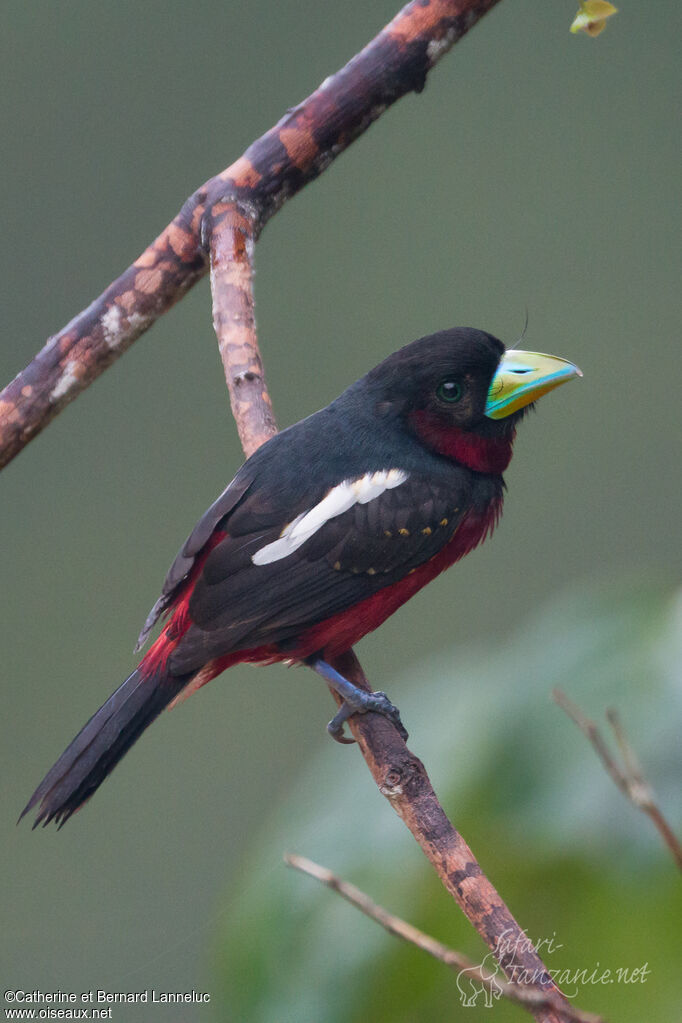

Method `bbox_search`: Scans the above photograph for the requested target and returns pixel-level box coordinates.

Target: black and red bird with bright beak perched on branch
[24,327,580,825]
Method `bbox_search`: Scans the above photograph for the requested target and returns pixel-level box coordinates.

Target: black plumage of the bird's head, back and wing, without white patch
[140,328,508,673]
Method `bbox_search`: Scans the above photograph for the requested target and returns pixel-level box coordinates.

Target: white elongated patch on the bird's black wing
[252,469,408,565]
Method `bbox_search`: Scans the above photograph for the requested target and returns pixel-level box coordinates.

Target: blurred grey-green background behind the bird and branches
[0,0,682,1023]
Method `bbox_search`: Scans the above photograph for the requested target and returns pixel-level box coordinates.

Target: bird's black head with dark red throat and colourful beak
[367,327,582,473]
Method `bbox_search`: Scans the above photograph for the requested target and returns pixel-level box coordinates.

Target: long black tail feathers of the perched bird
[19,668,189,828]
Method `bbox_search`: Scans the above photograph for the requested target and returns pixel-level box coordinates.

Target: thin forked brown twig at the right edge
[552,690,682,871]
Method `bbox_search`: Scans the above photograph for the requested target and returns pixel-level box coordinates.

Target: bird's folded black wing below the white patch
[171,473,470,674]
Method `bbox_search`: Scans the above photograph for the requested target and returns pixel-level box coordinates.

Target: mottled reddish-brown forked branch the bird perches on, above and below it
[0,0,593,1023]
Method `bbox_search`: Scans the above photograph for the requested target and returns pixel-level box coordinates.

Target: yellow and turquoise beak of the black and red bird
[485,349,583,419]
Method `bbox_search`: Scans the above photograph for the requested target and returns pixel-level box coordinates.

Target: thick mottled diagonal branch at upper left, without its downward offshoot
[0,0,498,468]
